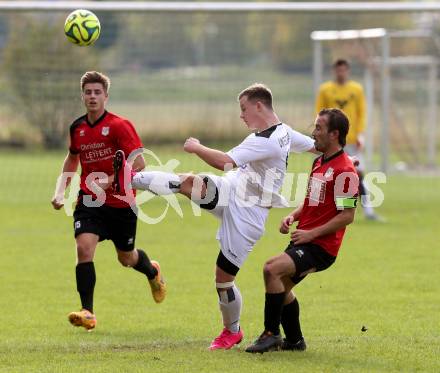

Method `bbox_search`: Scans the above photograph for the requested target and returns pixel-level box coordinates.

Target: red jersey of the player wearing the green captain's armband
[297,150,359,256]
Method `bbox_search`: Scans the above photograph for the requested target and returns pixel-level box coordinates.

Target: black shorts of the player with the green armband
[285,242,336,284]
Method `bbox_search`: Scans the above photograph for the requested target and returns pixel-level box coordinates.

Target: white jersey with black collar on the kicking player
[225,123,314,207]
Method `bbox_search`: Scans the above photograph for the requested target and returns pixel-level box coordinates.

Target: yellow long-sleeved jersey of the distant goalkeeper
[316,80,365,144]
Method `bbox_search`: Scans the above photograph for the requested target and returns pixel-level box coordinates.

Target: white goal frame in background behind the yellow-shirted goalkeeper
[311,28,438,172]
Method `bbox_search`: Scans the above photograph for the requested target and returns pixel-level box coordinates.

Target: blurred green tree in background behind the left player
[2,15,98,148]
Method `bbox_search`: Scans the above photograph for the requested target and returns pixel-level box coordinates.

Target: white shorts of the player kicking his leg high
[201,175,269,268]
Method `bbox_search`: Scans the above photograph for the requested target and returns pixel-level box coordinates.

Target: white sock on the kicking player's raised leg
[131,171,180,195]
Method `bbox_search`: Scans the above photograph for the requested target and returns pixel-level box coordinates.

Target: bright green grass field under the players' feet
[0,148,440,372]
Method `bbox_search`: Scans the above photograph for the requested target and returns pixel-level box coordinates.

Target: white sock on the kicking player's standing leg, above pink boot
[217,284,242,333]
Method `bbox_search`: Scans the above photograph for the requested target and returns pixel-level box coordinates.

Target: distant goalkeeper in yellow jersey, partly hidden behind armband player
[316,59,381,220]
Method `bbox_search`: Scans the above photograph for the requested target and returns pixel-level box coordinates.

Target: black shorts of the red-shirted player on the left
[73,197,137,251]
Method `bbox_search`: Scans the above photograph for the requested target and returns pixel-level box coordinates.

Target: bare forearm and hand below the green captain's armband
[290,208,356,245]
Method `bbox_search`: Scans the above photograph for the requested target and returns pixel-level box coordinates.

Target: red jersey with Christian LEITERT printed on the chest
[69,111,142,207]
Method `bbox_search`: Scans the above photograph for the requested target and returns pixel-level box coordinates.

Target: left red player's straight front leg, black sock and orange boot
[68,233,99,330]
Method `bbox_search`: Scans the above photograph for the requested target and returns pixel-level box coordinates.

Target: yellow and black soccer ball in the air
[64,9,101,46]
